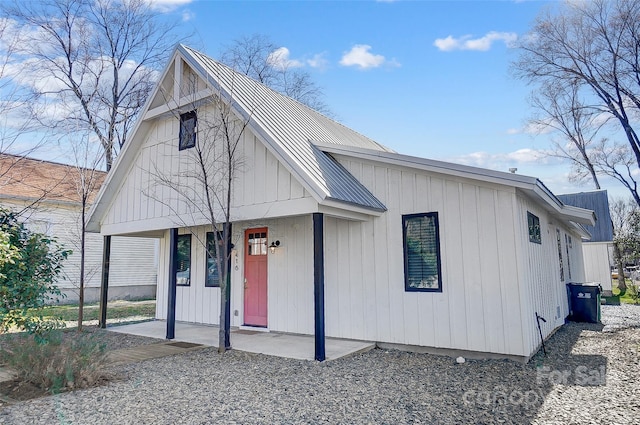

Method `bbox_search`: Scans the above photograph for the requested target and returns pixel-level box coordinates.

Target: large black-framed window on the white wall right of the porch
[402,212,442,292]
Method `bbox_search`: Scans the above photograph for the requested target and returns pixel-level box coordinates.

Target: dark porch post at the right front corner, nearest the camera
[313,213,326,362]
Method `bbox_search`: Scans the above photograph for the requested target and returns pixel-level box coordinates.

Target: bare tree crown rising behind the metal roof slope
[221,34,332,116]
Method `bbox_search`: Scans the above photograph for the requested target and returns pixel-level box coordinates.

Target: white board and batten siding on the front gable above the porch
[101,110,315,234]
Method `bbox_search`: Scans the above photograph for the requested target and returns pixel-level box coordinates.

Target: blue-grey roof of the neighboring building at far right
[558,190,613,242]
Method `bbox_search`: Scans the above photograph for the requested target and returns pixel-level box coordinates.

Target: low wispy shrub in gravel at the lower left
[0,330,107,393]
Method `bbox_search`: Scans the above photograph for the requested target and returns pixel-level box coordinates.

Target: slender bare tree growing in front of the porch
[146,65,250,353]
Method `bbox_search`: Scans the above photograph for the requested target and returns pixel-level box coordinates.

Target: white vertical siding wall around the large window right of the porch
[325,157,529,356]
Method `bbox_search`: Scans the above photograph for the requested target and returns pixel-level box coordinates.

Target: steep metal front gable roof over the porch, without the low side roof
[88,44,391,231]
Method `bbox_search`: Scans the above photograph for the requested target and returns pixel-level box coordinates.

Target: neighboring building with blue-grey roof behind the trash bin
[558,190,613,295]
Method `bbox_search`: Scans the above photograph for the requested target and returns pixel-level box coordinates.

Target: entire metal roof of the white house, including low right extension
[88,45,594,237]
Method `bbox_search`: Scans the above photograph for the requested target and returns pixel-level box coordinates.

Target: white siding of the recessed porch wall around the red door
[156,215,314,334]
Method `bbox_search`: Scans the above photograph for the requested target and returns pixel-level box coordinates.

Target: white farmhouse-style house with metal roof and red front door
[89,45,594,360]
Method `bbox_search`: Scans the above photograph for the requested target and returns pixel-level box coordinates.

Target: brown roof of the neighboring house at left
[0,154,107,203]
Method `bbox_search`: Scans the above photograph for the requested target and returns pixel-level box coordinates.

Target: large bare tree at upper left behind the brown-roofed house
[3,0,176,171]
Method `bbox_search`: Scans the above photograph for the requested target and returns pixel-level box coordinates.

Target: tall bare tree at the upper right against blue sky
[514,0,640,201]
